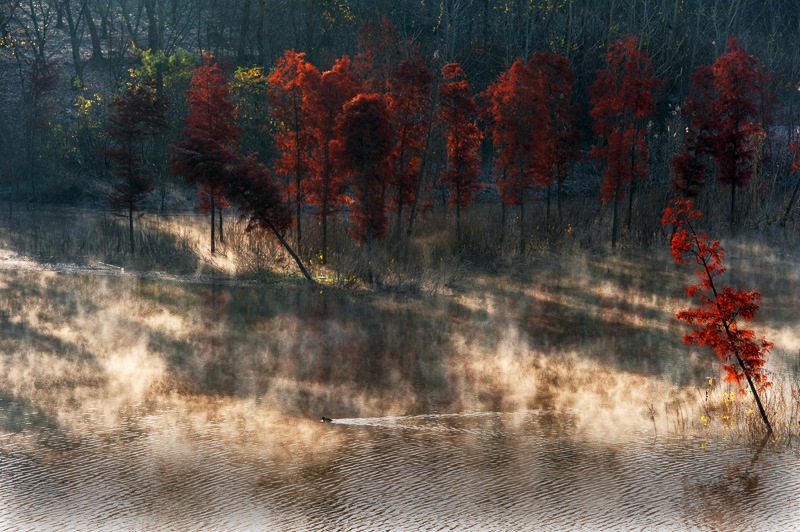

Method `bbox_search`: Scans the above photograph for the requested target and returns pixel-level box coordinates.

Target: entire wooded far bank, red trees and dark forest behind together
[0,0,800,277]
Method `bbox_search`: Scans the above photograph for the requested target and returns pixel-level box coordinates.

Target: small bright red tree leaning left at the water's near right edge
[661,199,772,433]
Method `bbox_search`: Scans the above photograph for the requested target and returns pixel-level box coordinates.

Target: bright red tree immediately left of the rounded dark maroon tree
[303,56,360,262]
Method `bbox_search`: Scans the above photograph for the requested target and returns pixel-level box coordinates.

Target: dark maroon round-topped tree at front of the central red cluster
[336,94,392,283]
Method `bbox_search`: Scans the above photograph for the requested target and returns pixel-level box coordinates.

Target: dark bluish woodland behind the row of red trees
[0,0,800,275]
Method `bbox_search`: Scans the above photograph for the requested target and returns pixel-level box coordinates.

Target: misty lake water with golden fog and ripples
[0,247,800,530]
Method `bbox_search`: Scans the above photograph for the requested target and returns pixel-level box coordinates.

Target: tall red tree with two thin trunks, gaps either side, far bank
[589,35,663,247]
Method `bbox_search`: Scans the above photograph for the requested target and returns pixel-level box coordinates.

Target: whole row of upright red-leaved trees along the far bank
[162,27,761,272]
